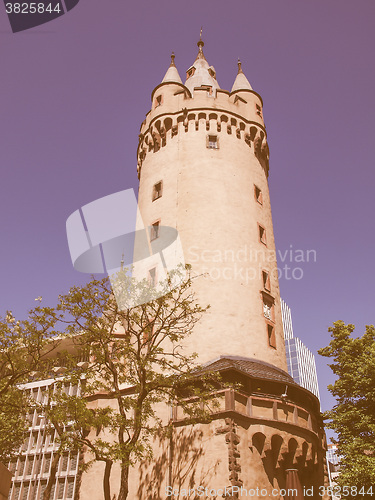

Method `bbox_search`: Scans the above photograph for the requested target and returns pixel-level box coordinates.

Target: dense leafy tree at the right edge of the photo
[318,321,375,498]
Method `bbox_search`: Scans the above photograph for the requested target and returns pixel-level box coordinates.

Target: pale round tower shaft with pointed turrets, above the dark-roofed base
[138,40,287,370]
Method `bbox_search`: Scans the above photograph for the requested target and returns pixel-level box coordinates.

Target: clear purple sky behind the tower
[0,0,375,422]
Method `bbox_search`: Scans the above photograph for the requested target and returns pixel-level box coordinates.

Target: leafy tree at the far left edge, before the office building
[0,305,57,463]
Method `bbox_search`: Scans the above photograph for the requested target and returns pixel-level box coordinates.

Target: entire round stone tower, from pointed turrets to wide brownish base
[131,39,326,500]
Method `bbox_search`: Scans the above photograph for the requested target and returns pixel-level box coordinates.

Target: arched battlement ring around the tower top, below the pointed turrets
[137,82,269,178]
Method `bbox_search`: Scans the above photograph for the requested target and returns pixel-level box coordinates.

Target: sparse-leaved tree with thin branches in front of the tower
[39,269,216,500]
